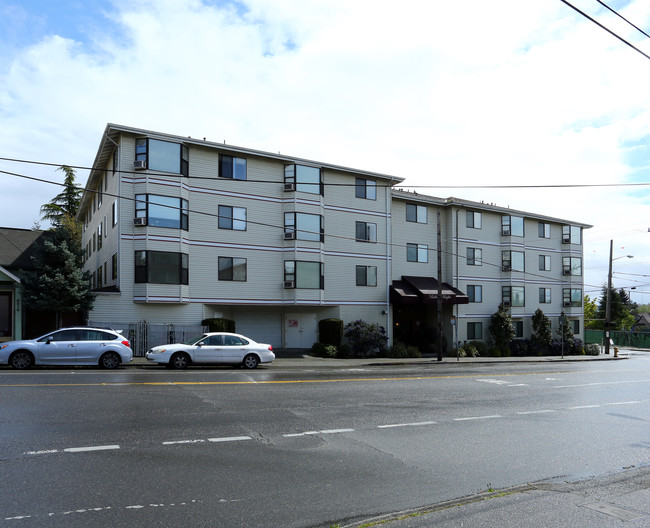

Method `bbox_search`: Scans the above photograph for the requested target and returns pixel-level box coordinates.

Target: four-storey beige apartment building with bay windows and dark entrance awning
[78,124,589,348]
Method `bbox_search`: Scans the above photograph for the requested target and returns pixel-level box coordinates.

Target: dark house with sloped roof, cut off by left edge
[0,227,43,342]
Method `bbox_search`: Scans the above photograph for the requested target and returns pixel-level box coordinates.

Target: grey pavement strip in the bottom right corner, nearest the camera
[338,465,650,528]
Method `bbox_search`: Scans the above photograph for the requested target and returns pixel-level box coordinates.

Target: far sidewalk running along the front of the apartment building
[125,349,632,369]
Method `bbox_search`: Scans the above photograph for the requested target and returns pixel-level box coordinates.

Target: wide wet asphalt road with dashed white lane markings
[0,356,650,528]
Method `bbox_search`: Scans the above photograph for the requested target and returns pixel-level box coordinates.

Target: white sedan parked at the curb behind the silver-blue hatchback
[146,332,275,369]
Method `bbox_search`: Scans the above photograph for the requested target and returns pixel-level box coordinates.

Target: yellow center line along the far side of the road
[0,371,576,388]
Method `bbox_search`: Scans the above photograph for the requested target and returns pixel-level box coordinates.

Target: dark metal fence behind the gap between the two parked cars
[88,321,208,357]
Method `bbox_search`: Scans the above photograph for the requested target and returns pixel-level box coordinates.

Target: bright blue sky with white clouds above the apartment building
[0,0,650,304]
